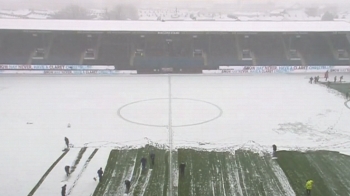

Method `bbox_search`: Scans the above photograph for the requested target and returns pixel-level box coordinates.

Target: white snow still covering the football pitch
[0,75,350,196]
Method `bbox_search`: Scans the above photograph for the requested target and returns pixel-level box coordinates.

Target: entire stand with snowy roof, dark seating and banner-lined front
[0,19,350,74]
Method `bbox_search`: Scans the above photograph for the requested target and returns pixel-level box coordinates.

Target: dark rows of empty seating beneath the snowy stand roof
[0,31,350,69]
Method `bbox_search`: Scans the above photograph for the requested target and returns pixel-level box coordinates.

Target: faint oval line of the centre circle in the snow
[118,98,223,127]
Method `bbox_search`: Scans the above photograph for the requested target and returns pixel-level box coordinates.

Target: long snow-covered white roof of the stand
[0,19,350,32]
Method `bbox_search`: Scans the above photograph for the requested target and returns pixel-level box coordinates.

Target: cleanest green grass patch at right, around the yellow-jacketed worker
[277,151,350,196]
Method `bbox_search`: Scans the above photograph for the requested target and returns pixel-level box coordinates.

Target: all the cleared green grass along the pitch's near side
[30,148,350,196]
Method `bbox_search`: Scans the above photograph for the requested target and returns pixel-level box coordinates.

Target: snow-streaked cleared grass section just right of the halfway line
[178,149,291,196]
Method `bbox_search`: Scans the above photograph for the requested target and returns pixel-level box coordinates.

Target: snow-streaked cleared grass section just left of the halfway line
[93,146,169,196]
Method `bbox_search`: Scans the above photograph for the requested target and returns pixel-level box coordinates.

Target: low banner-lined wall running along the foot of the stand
[0,64,350,75]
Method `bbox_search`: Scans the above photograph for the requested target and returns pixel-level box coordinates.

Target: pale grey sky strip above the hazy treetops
[0,0,350,9]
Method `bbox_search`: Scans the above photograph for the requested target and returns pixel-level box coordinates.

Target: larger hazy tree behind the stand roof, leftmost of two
[51,5,93,20]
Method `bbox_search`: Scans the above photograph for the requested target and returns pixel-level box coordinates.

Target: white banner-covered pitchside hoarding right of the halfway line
[203,65,350,74]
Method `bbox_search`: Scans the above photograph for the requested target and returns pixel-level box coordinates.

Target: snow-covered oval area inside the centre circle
[118,98,222,127]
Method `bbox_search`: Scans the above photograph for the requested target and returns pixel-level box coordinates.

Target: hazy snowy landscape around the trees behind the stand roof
[0,1,350,21]
